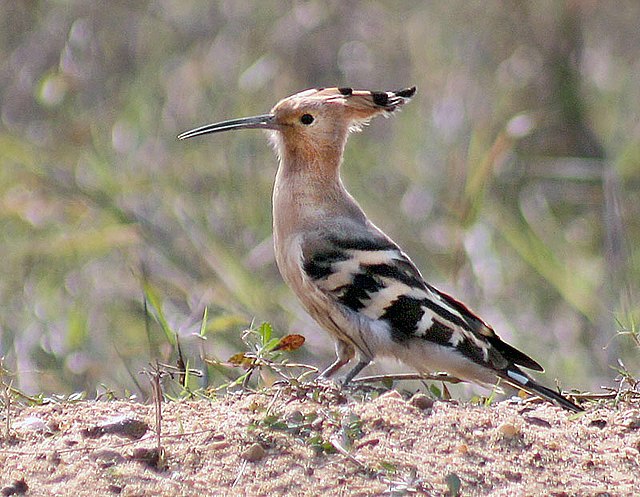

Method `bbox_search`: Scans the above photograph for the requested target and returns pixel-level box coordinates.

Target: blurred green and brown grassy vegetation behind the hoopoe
[0,0,640,393]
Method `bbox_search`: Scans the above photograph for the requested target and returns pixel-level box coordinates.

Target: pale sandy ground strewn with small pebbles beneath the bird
[0,387,640,497]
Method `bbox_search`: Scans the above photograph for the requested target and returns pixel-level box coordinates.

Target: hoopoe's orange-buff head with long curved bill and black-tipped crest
[178,86,416,162]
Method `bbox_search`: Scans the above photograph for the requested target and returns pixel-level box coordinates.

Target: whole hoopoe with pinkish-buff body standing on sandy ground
[178,87,582,412]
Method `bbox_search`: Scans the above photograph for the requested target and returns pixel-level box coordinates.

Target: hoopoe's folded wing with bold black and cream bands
[302,226,542,372]
